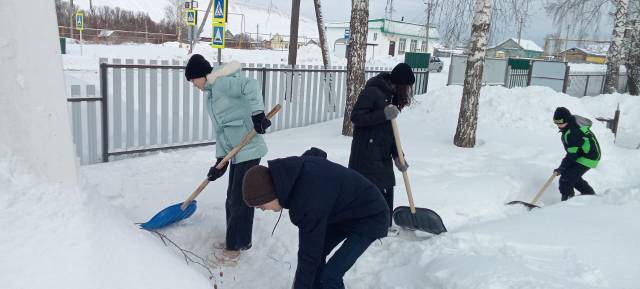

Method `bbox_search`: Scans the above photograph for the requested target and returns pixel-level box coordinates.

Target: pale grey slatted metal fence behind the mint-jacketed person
[68,59,429,164]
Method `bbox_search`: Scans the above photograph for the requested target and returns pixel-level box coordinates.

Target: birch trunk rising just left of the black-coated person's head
[342,0,369,136]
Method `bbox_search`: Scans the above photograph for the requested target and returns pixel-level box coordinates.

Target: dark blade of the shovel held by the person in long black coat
[393,206,447,235]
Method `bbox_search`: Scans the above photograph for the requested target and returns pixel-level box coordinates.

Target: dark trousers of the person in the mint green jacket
[225,159,260,251]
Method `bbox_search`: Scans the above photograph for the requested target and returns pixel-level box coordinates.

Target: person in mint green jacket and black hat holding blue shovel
[185,54,271,262]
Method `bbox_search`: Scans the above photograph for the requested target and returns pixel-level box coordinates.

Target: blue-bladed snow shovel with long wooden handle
[140,104,281,230]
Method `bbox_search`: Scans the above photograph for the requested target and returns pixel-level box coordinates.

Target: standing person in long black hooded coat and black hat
[349,63,415,226]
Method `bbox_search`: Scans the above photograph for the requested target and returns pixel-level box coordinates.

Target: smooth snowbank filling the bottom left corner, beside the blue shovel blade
[0,147,210,288]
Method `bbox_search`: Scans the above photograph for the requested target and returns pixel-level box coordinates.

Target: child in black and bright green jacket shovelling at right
[553,107,600,201]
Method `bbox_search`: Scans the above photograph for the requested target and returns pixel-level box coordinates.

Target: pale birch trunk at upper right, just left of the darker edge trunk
[604,0,629,93]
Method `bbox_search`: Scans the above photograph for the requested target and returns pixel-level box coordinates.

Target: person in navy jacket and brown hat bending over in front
[243,148,390,289]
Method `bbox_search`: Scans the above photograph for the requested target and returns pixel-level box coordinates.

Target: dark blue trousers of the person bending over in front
[313,226,375,289]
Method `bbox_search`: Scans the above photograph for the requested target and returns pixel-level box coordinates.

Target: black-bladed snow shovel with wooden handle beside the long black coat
[391,119,447,235]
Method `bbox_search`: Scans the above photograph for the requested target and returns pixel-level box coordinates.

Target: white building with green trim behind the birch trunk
[325,18,440,59]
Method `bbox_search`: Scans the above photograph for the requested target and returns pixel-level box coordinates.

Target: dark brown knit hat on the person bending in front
[242,165,277,207]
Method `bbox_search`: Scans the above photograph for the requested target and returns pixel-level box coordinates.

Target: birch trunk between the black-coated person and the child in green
[453,0,491,148]
